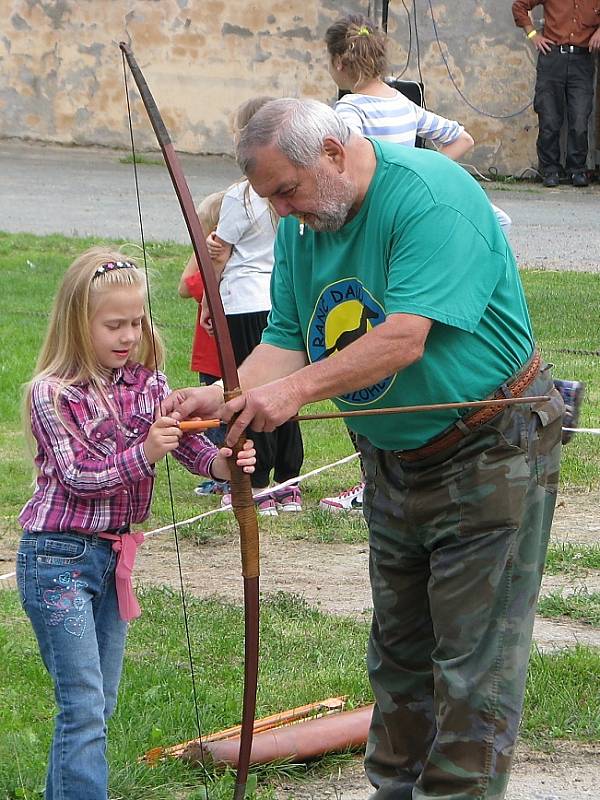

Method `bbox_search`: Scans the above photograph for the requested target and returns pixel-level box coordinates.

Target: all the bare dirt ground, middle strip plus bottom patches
[0,493,600,800]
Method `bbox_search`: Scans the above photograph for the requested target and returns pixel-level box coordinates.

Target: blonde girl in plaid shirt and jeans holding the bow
[17,247,255,800]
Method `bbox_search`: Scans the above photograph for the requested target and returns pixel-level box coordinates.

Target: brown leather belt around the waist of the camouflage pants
[395,350,541,462]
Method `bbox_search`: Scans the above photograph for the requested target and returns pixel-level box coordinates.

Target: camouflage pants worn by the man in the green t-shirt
[359,368,563,800]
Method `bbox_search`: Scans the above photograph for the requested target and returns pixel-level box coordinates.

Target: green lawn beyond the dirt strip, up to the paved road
[0,228,600,542]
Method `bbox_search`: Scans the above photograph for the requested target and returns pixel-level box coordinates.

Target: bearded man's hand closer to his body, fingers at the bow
[220,376,302,447]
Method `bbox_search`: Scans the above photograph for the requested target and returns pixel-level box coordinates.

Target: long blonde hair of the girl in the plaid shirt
[23,247,164,454]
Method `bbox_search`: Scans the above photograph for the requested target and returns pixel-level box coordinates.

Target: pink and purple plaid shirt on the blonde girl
[19,364,217,533]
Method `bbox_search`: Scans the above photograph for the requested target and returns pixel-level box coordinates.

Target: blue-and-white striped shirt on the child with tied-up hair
[335,91,464,147]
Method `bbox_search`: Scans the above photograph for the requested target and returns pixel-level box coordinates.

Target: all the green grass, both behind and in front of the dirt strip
[0,233,600,800]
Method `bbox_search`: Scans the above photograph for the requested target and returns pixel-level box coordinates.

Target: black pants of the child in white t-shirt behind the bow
[227,311,304,489]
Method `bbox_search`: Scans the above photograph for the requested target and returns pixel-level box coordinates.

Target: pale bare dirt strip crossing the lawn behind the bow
[131,494,600,648]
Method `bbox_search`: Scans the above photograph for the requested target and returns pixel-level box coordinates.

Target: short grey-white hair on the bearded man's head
[235,97,351,174]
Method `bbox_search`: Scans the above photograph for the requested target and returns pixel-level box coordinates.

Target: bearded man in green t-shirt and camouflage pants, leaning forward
[166,99,563,800]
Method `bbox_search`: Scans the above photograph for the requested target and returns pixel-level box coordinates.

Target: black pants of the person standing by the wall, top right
[533,47,594,175]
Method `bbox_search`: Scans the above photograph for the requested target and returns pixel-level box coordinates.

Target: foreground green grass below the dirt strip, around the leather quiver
[0,589,600,800]
